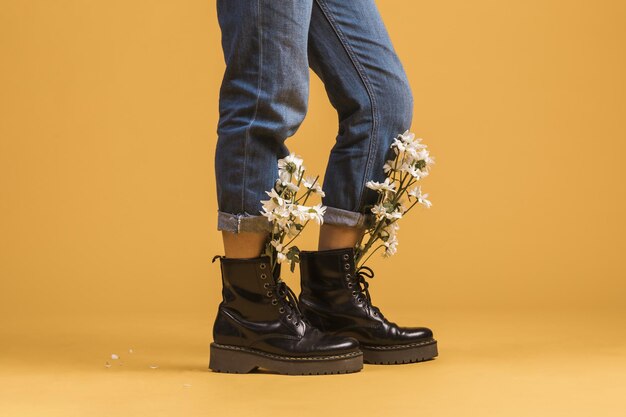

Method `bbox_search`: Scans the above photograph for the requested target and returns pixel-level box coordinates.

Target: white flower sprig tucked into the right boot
[354,130,435,269]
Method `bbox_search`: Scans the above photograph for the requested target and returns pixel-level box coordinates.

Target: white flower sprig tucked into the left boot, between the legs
[261,152,326,272]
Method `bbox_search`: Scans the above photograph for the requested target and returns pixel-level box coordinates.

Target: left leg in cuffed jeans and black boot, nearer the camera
[209,0,363,375]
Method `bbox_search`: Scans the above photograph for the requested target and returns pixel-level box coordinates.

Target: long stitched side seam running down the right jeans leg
[315,0,378,212]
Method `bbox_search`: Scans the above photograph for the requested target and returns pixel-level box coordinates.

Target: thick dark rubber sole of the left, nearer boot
[209,342,363,375]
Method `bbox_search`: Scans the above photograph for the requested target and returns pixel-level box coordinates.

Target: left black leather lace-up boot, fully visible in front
[209,255,363,375]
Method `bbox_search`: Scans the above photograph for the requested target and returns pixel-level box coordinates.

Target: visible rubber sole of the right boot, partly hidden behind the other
[360,339,439,365]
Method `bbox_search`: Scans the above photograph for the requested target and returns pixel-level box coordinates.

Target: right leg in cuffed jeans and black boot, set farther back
[299,0,438,364]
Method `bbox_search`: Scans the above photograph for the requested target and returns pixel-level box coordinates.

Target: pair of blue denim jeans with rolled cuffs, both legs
[215,0,413,233]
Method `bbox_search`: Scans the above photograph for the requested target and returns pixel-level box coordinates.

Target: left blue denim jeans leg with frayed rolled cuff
[215,0,313,233]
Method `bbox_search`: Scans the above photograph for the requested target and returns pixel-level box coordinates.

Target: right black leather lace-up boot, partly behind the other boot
[299,247,438,364]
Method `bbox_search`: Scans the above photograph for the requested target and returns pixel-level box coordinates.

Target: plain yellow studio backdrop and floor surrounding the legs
[0,0,626,416]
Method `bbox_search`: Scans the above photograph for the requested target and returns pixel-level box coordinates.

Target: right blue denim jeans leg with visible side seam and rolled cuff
[308,0,413,226]
